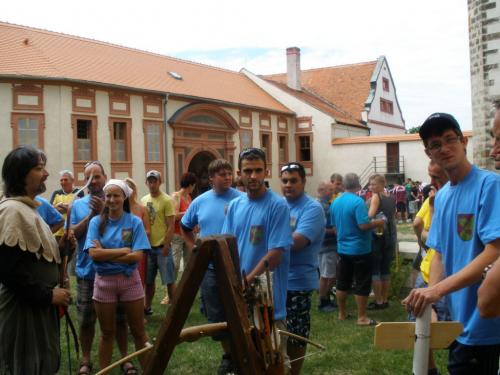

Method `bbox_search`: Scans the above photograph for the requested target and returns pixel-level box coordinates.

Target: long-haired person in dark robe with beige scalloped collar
[0,146,71,375]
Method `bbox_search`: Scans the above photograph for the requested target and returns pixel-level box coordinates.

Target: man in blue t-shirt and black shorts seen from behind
[330,173,384,326]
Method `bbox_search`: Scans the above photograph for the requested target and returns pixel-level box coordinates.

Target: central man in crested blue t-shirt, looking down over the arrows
[222,148,292,370]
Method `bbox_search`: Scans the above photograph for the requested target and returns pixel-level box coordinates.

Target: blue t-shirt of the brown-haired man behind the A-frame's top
[181,188,244,237]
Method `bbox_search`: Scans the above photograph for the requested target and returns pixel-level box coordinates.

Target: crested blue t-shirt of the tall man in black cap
[427,166,500,345]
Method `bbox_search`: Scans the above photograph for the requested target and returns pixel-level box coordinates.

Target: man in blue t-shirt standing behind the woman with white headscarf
[69,161,131,373]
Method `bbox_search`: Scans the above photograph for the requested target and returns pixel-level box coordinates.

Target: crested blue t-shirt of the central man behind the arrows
[222,190,292,320]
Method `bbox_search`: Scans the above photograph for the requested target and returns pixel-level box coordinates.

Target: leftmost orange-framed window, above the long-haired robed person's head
[11,113,45,149]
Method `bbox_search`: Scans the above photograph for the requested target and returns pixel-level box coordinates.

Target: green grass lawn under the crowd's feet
[59,272,447,375]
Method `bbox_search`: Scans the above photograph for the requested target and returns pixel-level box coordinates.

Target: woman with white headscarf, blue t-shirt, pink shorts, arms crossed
[85,179,151,369]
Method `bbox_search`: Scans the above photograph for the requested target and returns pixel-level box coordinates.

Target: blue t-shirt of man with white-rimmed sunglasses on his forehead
[287,194,326,291]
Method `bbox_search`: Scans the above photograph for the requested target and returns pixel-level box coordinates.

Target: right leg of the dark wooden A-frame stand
[214,237,265,375]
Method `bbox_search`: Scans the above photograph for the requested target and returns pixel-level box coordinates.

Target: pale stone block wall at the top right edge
[468,0,500,170]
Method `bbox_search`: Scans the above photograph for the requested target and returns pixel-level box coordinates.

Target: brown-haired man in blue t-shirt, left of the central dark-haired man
[181,159,243,374]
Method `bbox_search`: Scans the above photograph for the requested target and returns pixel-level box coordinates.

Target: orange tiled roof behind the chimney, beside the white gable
[263,61,377,125]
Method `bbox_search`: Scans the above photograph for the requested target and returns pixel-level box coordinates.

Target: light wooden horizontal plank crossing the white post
[374,322,463,350]
